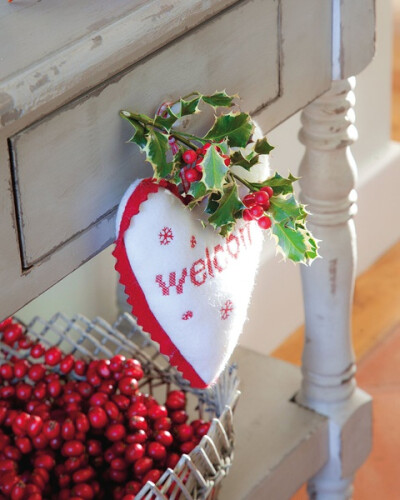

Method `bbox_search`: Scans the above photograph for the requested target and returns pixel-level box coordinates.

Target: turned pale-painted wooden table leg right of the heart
[297,78,371,500]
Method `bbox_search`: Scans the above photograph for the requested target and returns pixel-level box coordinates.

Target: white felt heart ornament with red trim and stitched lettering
[113,179,263,388]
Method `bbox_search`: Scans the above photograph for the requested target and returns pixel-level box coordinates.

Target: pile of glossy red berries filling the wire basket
[0,318,210,500]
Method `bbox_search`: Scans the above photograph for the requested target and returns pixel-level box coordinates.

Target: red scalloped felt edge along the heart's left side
[112,179,209,389]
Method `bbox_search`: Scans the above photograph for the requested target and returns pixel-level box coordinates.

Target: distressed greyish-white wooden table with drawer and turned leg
[0,0,374,500]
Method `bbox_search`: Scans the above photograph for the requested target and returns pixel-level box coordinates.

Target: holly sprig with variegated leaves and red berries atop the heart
[120,91,318,264]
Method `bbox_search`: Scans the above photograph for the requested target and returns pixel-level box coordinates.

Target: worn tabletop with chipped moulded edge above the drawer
[0,0,241,129]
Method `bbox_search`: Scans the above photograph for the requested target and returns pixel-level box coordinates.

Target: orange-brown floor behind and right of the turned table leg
[274,0,400,500]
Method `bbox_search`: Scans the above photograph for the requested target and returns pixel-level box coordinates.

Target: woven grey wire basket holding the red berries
[0,313,240,500]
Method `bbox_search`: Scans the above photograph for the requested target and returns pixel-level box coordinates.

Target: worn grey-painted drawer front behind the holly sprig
[10,0,280,269]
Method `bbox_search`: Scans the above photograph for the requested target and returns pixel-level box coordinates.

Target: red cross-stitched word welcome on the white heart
[155,224,252,295]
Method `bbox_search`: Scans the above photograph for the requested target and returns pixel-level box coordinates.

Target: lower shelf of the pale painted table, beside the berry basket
[218,348,328,500]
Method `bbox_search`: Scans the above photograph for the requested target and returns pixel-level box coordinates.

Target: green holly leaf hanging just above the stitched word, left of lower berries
[208,183,245,236]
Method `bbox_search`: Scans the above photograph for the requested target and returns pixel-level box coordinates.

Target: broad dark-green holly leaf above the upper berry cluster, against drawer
[204,113,254,148]
